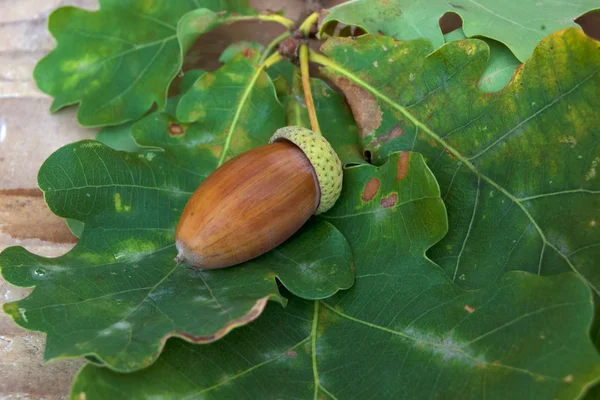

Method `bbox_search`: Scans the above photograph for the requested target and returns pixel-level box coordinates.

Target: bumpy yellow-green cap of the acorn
[269,126,343,215]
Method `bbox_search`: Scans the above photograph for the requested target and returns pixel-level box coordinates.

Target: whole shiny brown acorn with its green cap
[175,126,342,269]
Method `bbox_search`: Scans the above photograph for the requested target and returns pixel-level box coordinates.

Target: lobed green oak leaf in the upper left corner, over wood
[34,0,256,126]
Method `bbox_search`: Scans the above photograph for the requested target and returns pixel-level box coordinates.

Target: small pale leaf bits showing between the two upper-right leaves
[444,28,521,93]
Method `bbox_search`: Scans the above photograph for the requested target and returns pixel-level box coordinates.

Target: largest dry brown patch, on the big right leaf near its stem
[334,77,383,138]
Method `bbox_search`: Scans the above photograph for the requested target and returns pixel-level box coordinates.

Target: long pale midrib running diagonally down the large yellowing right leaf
[311,54,600,295]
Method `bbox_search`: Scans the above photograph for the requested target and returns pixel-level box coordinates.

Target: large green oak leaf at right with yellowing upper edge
[314,28,600,293]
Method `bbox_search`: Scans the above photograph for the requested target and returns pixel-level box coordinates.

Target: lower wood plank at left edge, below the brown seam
[0,189,83,400]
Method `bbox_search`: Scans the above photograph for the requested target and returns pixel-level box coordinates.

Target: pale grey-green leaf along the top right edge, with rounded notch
[320,0,600,61]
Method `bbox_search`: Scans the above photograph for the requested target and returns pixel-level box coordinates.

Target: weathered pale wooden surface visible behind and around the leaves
[0,0,600,400]
